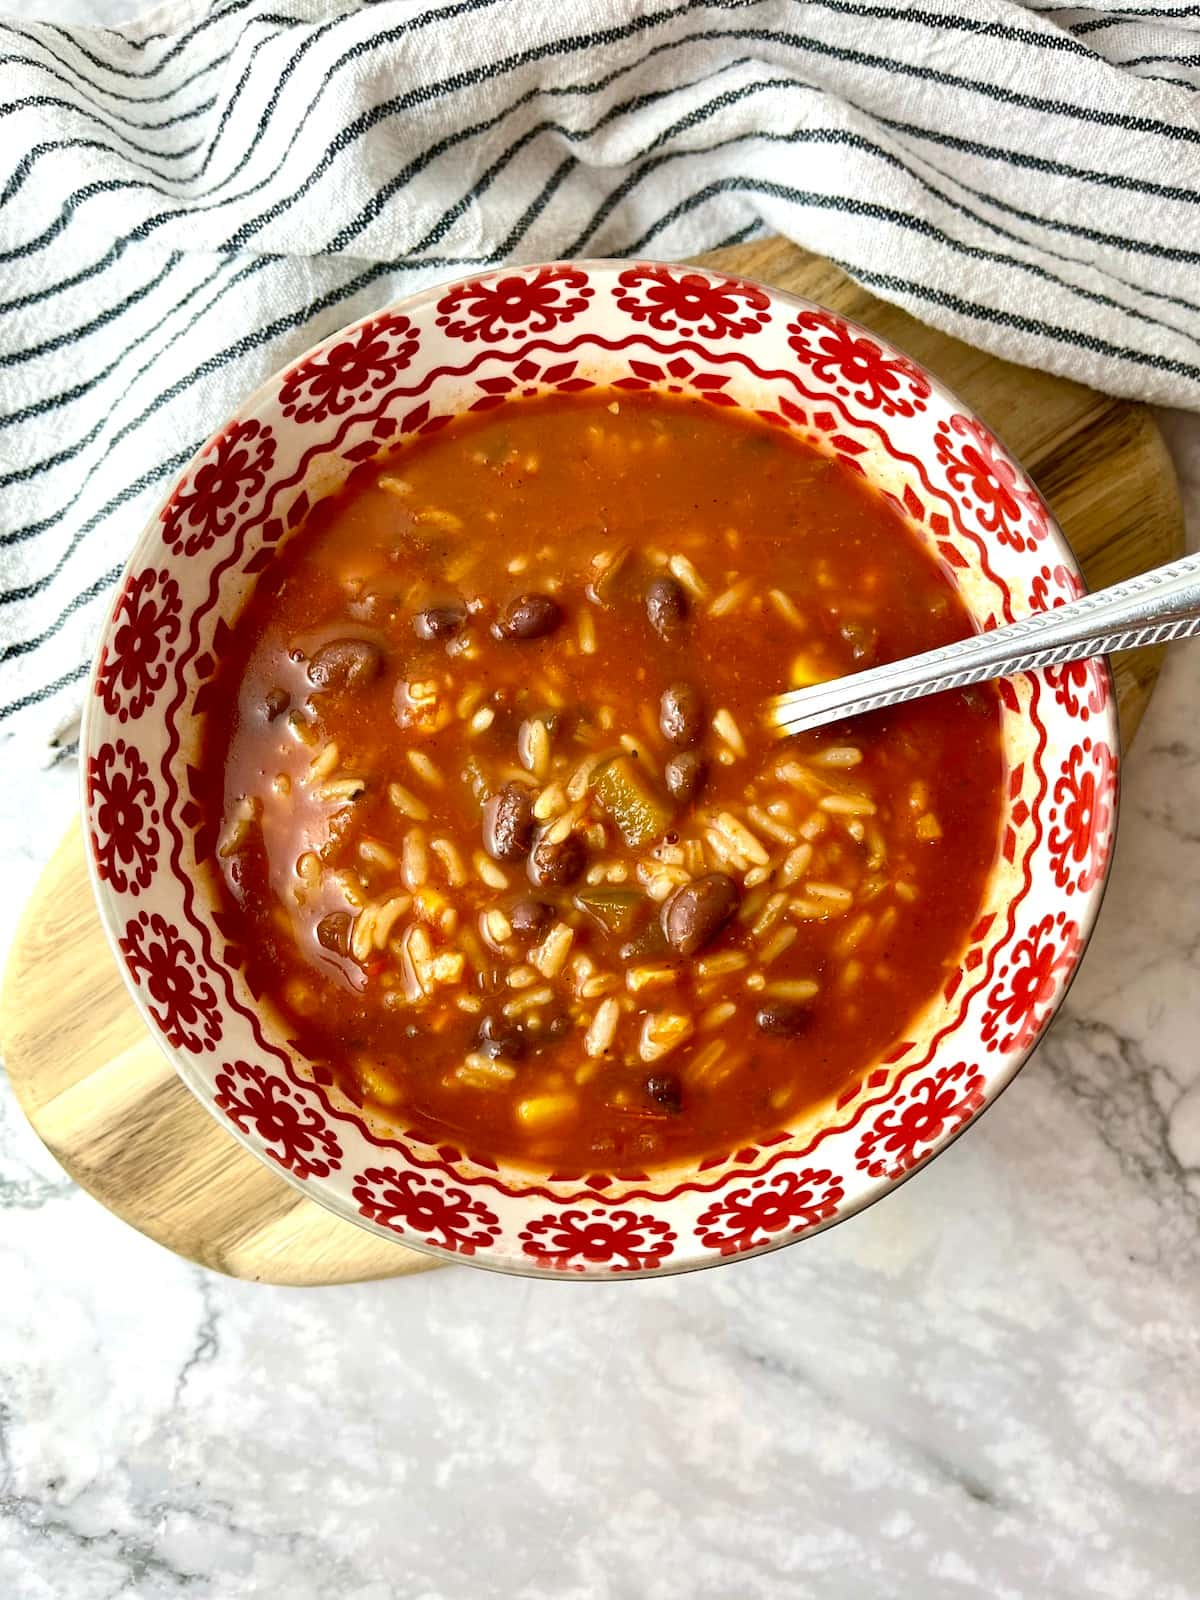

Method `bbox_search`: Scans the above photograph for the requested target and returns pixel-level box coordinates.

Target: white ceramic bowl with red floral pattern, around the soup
[83,261,1118,1278]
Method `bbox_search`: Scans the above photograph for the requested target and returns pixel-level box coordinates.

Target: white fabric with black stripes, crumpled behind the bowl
[0,0,1200,758]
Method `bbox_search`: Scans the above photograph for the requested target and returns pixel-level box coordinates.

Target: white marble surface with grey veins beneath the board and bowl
[0,0,1200,1600]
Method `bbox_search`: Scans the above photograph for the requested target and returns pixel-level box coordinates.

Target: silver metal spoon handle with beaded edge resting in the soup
[766,555,1200,738]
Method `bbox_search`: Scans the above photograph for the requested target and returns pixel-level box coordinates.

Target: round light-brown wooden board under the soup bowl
[0,240,1184,1285]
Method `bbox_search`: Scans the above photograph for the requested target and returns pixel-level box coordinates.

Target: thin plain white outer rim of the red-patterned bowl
[78,256,1125,1283]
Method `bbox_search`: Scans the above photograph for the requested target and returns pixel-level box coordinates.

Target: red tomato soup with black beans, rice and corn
[202,392,1003,1171]
